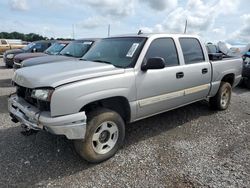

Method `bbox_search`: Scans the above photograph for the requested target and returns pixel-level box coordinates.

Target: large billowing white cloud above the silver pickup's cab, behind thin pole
[142,0,238,34]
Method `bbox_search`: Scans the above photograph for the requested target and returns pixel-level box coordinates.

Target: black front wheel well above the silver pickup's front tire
[80,96,131,122]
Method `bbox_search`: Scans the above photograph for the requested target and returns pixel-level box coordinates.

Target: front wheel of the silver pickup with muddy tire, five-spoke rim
[74,109,125,163]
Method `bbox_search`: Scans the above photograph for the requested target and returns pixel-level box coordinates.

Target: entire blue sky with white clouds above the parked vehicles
[0,0,250,44]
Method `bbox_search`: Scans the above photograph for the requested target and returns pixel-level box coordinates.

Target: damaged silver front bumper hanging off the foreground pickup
[8,94,87,139]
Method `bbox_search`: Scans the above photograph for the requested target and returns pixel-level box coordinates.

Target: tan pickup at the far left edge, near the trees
[0,39,26,54]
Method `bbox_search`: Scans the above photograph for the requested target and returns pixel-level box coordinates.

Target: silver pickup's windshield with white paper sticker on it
[83,37,146,68]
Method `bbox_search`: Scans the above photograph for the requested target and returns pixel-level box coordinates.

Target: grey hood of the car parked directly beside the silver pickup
[22,55,75,67]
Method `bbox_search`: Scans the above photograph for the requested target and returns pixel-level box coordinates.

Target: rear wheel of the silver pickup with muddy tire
[209,82,232,110]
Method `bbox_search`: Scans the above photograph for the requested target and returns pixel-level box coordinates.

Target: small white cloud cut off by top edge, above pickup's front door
[140,0,178,11]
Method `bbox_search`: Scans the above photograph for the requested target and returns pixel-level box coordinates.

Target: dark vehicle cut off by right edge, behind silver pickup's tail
[242,51,250,89]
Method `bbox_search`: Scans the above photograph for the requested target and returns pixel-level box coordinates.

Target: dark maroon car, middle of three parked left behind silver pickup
[13,41,70,69]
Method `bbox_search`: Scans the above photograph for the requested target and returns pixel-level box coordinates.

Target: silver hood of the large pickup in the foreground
[13,60,125,88]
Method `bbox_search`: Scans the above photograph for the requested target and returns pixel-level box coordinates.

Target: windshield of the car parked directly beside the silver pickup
[60,41,93,58]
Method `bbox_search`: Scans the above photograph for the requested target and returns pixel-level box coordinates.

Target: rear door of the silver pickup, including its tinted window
[179,37,212,103]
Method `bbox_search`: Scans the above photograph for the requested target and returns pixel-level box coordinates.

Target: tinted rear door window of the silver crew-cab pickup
[179,38,205,64]
